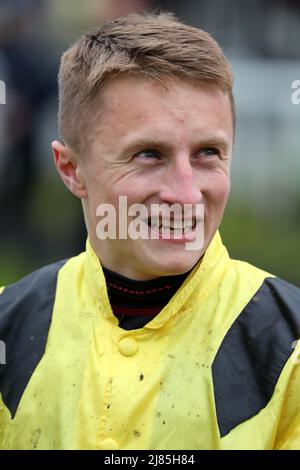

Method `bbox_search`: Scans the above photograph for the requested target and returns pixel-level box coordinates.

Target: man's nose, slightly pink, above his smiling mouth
[160,161,203,205]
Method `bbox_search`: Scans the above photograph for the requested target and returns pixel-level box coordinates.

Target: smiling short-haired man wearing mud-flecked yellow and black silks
[0,14,300,450]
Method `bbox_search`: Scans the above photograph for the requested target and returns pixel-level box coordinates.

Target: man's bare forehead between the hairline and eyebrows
[88,76,233,145]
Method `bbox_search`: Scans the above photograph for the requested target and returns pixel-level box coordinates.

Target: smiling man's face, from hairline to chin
[80,77,233,280]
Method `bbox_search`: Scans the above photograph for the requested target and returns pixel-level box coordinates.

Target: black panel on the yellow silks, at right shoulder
[212,278,300,437]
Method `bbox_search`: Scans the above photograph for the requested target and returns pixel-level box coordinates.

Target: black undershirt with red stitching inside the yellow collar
[103,268,190,330]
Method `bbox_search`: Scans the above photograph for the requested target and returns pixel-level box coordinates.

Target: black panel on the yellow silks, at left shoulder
[0,261,66,417]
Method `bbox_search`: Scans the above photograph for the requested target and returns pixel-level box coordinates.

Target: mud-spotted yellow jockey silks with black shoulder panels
[0,233,300,450]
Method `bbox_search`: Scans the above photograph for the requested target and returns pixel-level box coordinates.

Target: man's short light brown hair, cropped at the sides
[58,13,235,152]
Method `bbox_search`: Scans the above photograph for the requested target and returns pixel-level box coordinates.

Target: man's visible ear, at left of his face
[52,140,87,199]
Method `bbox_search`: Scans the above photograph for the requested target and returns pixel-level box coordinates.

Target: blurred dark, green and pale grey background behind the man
[0,0,300,286]
